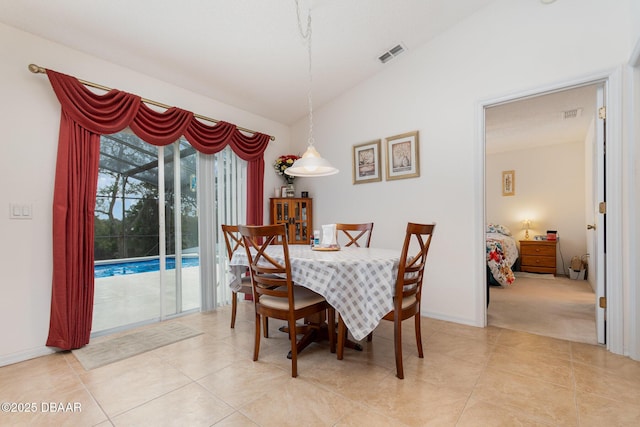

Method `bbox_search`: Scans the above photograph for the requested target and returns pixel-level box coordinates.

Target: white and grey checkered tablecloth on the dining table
[229,245,400,340]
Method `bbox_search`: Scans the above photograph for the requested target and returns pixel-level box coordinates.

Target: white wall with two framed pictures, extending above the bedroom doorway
[292,0,630,325]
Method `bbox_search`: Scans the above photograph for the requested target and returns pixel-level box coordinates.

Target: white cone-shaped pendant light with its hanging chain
[284,0,339,177]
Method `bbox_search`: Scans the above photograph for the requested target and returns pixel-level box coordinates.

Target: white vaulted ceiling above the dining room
[0,0,588,150]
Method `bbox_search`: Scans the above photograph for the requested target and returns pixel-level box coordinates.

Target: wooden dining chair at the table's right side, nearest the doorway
[337,222,435,379]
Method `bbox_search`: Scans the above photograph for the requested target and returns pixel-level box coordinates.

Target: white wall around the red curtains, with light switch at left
[0,24,289,366]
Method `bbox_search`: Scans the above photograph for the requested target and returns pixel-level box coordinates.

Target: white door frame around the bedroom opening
[475,67,624,354]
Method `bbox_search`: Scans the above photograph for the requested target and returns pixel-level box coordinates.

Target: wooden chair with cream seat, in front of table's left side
[238,224,335,377]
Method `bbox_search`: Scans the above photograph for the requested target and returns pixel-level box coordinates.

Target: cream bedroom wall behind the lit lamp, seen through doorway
[486,142,587,275]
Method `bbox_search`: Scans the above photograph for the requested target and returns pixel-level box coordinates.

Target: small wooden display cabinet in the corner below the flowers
[269,197,313,245]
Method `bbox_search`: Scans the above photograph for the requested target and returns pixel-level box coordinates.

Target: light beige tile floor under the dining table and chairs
[0,302,640,427]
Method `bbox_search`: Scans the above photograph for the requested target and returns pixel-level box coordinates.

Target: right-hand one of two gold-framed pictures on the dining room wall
[386,131,420,180]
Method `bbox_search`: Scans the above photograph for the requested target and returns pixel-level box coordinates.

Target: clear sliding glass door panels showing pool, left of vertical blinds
[92,131,200,334]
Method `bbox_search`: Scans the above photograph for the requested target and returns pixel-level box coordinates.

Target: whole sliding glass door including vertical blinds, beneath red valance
[92,130,247,334]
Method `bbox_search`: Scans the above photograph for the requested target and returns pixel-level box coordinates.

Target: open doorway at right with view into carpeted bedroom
[484,81,605,343]
